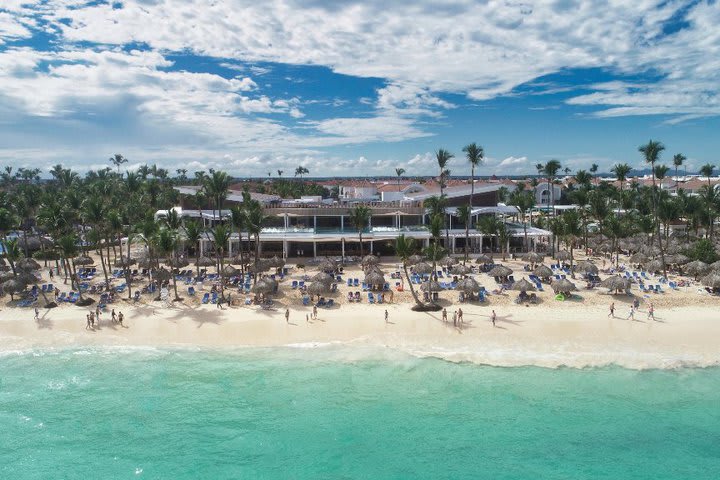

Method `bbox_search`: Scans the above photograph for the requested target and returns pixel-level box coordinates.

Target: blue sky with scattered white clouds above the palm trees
[0,0,720,177]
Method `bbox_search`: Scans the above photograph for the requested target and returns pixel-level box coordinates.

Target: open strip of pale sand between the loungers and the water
[0,303,720,370]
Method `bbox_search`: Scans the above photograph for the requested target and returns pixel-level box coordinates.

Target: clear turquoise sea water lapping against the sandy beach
[0,348,720,479]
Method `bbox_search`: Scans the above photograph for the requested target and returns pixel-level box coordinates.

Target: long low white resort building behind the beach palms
[156,180,550,258]
